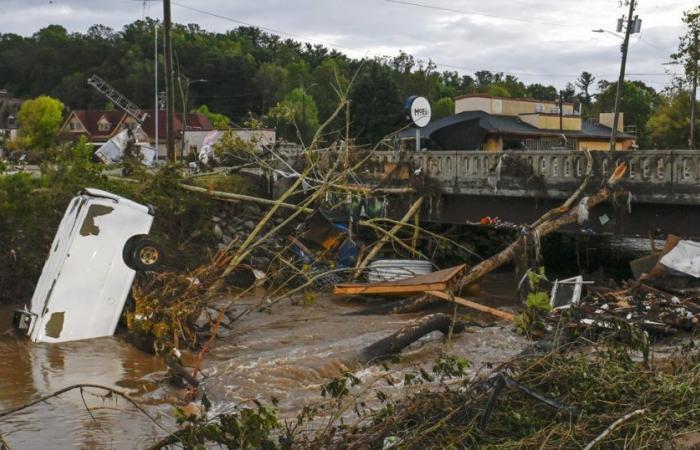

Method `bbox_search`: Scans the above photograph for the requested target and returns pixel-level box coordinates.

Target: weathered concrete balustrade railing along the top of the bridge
[375,150,700,204]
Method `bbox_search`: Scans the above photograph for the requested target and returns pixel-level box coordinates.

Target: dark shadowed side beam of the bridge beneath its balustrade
[429,194,700,239]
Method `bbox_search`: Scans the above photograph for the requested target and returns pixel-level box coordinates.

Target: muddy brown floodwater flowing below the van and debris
[0,274,527,448]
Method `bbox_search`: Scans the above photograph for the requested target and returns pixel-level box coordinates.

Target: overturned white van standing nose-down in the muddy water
[14,189,162,343]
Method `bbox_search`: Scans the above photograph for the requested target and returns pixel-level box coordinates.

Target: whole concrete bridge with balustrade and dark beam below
[376,150,700,237]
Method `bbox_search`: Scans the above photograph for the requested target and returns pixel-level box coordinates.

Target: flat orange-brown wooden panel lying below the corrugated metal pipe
[333,264,466,295]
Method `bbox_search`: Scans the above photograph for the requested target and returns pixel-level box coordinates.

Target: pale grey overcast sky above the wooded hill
[0,0,696,89]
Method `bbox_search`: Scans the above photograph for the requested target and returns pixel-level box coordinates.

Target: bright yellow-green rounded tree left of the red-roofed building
[17,95,63,150]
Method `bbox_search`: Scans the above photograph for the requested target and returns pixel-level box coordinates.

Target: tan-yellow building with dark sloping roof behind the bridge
[400,94,635,151]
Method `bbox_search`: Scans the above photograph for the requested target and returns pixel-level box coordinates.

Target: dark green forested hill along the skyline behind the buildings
[0,20,680,146]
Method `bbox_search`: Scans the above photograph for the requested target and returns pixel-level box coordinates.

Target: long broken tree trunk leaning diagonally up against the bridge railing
[460,154,627,286]
